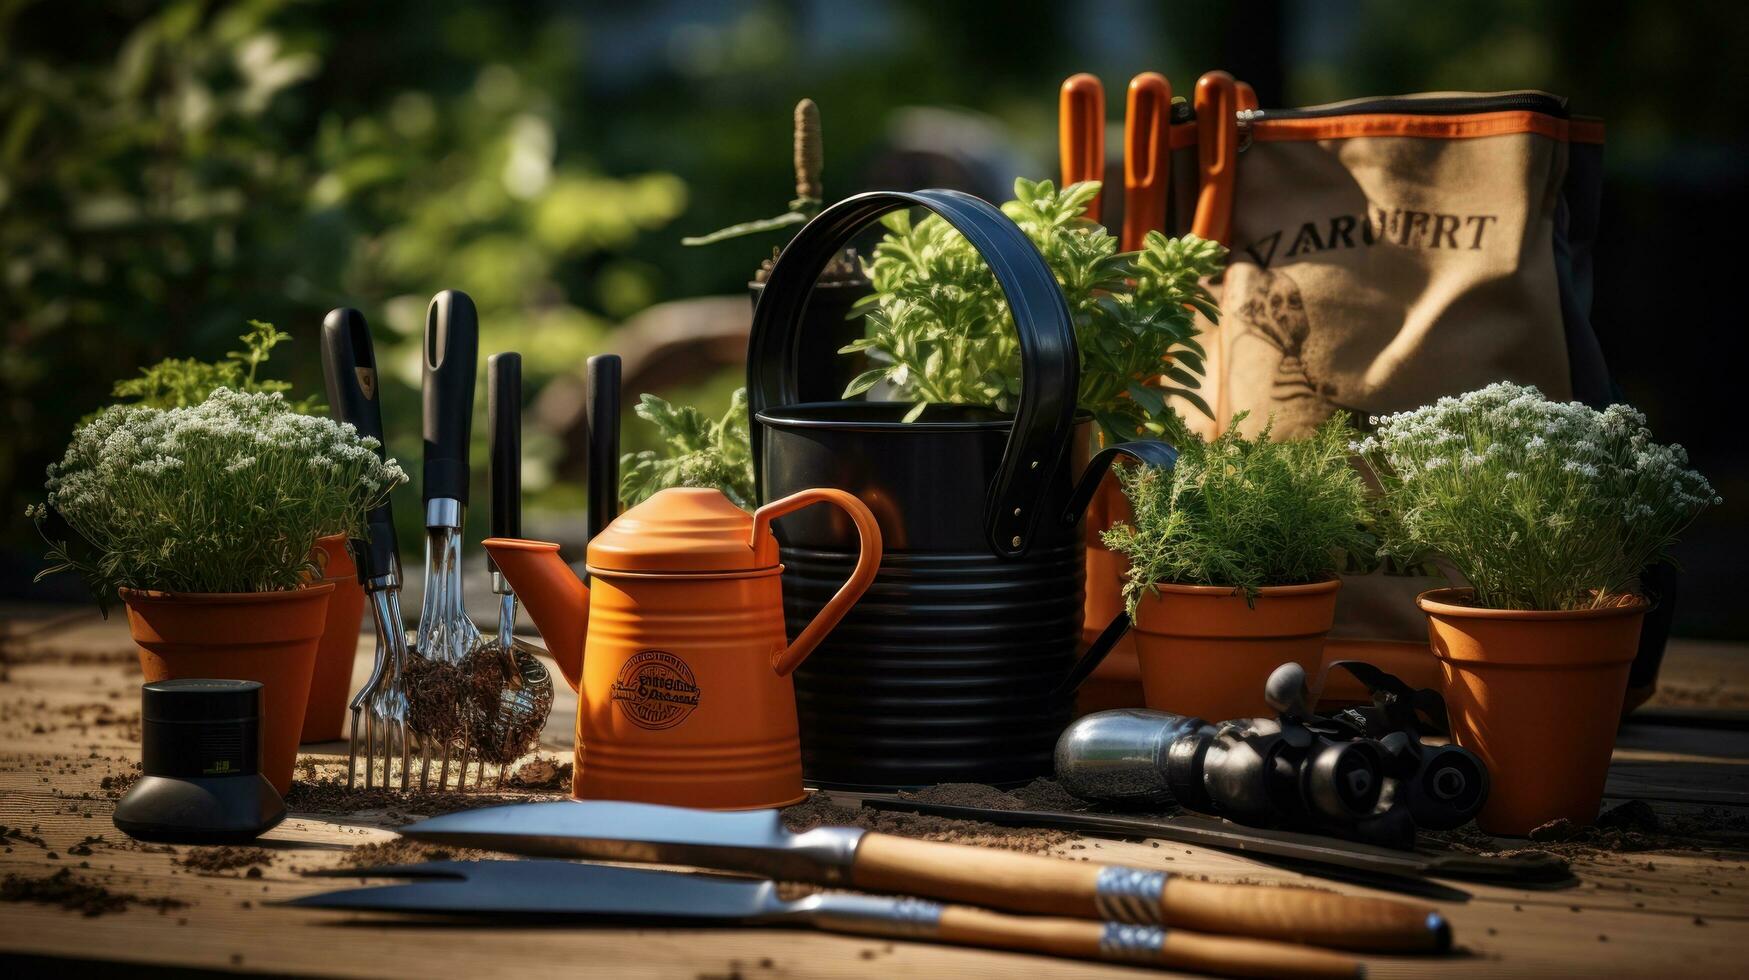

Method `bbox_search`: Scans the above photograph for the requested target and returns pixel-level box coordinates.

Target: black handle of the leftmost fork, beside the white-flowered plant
[322,306,395,583]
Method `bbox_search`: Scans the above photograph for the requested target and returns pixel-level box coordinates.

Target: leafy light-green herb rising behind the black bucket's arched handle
[841,179,1226,441]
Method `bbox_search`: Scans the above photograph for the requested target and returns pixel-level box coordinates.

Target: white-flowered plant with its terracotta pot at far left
[31,389,406,793]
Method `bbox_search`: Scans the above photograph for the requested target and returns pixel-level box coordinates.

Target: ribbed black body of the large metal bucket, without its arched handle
[759,403,1088,789]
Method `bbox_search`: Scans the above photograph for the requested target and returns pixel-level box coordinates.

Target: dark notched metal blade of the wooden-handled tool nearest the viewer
[287,861,785,922]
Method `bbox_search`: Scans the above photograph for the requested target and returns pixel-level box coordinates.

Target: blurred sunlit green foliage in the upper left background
[0,0,686,560]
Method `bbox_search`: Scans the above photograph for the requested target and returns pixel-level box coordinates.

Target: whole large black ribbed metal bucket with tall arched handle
[747,191,1174,789]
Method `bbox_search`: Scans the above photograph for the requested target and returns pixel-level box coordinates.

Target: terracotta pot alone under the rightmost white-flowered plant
[1415,588,1648,835]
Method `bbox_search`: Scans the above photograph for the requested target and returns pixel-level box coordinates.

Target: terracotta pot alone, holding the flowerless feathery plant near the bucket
[1132,579,1341,721]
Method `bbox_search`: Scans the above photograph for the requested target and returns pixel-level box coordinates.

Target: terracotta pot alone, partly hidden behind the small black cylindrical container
[121,583,334,796]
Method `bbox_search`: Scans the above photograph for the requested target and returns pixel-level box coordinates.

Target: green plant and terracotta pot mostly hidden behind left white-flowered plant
[110,320,364,742]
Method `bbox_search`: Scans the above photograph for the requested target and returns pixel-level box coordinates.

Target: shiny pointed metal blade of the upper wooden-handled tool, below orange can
[401,800,862,884]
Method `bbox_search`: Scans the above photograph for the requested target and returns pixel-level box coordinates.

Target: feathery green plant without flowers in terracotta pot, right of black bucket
[1105,413,1375,721]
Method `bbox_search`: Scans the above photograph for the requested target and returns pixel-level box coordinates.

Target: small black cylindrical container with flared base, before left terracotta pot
[115,679,285,844]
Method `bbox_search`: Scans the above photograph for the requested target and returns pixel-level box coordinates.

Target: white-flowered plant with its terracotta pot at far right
[1357,383,1721,835]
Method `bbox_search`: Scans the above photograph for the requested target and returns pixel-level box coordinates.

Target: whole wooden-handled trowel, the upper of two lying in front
[402,800,1452,952]
